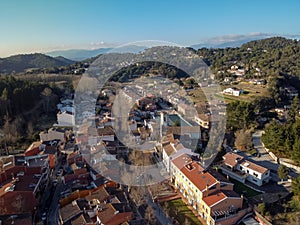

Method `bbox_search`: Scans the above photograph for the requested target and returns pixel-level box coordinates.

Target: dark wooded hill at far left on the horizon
[0,53,74,73]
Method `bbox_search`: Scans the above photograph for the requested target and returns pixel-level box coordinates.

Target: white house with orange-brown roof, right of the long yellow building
[220,152,271,186]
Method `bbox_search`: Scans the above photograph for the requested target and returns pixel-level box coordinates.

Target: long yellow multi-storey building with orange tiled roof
[171,154,250,225]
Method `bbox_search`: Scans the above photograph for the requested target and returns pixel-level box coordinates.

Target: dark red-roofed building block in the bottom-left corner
[0,156,47,219]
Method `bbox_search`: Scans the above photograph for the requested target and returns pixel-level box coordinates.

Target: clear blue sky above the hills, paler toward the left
[0,0,300,57]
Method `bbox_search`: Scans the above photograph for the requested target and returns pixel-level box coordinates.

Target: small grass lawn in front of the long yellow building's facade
[163,199,203,225]
